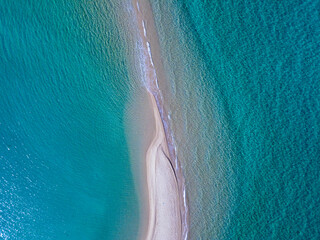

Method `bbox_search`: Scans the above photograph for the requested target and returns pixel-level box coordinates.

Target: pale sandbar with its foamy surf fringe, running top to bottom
[132,0,188,240]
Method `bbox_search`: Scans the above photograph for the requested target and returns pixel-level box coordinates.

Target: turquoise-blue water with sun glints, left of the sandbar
[0,0,139,240]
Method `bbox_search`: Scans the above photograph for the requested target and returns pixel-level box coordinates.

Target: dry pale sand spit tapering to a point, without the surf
[145,93,181,240]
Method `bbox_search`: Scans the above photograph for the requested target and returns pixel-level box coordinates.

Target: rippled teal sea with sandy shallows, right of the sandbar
[151,0,320,239]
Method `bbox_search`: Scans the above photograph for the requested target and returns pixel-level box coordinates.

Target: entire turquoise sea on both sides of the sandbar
[0,0,320,240]
